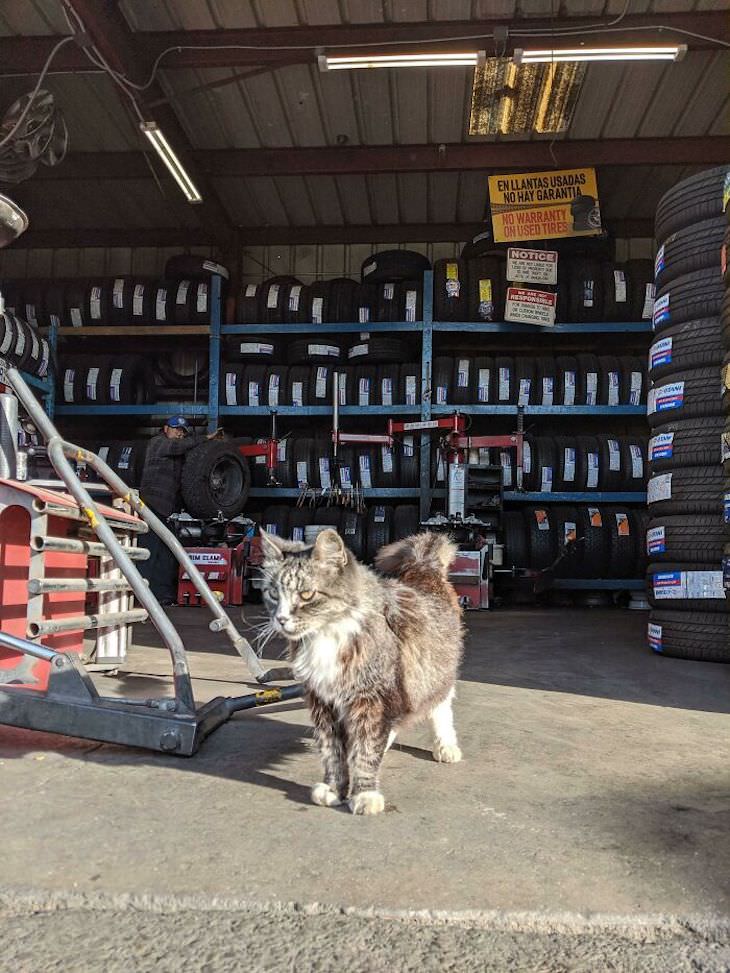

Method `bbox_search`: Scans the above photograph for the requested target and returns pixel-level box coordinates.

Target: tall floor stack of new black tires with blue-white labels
[647,167,730,662]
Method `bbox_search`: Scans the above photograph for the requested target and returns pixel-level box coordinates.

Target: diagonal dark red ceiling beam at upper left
[67,0,233,248]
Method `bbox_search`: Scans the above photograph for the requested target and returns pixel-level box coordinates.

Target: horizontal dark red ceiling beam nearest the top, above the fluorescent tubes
[0,12,730,75]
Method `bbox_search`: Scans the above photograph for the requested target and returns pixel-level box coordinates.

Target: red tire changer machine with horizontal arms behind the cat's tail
[332,376,524,609]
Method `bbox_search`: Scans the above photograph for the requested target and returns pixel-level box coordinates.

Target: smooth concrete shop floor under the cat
[0,609,730,970]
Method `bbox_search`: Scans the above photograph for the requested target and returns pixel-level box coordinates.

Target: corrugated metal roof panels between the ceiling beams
[0,0,730,235]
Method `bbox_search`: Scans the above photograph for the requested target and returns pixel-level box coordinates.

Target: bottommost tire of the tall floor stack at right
[648,609,730,662]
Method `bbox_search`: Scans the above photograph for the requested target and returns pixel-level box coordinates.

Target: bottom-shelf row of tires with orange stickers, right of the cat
[502,504,647,587]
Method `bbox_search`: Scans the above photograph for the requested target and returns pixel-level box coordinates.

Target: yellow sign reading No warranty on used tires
[489,169,601,243]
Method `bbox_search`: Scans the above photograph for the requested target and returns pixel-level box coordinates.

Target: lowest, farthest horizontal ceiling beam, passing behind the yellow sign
[13,219,654,250]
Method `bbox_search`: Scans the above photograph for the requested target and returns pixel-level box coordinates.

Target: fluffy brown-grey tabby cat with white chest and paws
[261,530,463,814]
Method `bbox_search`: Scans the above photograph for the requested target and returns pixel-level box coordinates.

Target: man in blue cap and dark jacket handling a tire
[139,416,218,605]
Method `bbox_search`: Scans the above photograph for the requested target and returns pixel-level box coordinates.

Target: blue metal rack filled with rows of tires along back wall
[11,244,653,590]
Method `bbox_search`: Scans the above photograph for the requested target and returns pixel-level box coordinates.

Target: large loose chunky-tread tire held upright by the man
[181,439,251,519]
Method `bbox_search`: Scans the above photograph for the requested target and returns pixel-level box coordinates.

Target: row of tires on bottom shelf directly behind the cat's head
[260,504,419,562]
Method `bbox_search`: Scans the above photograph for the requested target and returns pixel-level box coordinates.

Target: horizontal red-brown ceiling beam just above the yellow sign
[29,136,730,181]
